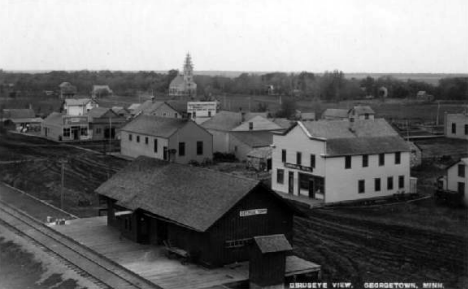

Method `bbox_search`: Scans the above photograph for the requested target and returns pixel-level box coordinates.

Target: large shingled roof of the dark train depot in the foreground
[96,157,264,232]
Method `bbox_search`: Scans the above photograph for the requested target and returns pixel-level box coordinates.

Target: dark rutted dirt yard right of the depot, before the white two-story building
[294,199,468,288]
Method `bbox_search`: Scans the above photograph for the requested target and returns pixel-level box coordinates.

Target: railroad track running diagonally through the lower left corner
[0,201,161,289]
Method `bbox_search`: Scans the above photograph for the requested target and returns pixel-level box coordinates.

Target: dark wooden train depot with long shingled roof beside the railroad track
[97,157,320,284]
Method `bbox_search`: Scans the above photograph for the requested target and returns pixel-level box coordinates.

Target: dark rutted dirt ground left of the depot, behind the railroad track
[0,130,128,217]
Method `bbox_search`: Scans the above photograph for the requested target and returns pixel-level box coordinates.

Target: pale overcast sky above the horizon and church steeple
[0,0,468,73]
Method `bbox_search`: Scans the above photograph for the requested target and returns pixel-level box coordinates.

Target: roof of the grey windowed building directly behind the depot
[121,114,190,138]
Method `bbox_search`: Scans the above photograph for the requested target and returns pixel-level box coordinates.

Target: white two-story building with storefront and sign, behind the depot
[272,119,410,203]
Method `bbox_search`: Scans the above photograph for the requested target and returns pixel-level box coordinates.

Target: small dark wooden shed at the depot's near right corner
[249,234,292,288]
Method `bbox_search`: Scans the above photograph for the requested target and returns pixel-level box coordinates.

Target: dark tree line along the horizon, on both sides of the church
[0,69,468,101]
